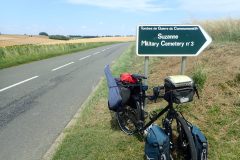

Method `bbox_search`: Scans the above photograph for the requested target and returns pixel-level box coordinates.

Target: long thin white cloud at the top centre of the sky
[67,0,171,12]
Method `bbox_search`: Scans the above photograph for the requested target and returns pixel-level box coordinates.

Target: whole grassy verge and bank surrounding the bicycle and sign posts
[53,43,240,160]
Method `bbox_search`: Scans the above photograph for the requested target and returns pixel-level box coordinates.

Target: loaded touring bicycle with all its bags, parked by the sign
[104,65,208,160]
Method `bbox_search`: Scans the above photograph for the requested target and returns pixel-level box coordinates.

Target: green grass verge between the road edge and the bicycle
[53,43,146,160]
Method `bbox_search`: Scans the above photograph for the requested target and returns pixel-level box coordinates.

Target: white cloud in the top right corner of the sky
[178,0,240,14]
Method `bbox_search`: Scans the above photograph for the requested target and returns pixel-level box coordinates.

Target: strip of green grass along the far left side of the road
[0,42,113,69]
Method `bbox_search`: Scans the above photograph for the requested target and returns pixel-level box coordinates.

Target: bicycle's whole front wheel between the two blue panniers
[173,114,197,160]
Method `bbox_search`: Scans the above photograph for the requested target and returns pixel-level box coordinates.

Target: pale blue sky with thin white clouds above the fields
[0,0,240,36]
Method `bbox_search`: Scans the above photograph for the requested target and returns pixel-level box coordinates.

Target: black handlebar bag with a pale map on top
[164,75,196,104]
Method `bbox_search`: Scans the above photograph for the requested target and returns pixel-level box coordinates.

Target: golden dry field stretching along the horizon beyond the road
[0,35,135,47]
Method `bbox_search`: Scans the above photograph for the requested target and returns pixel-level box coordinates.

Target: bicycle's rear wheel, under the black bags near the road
[115,101,141,135]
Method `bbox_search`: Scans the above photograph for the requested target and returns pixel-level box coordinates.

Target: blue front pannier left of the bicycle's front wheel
[144,125,170,160]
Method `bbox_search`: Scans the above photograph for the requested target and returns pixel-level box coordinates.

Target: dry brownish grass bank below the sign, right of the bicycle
[148,43,240,159]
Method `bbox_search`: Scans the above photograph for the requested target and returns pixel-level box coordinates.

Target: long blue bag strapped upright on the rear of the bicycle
[104,65,122,111]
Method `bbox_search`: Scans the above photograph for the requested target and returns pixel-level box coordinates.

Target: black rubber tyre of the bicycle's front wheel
[176,114,197,160]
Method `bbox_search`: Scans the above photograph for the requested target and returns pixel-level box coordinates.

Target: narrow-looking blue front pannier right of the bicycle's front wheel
[191,125,208,160]
